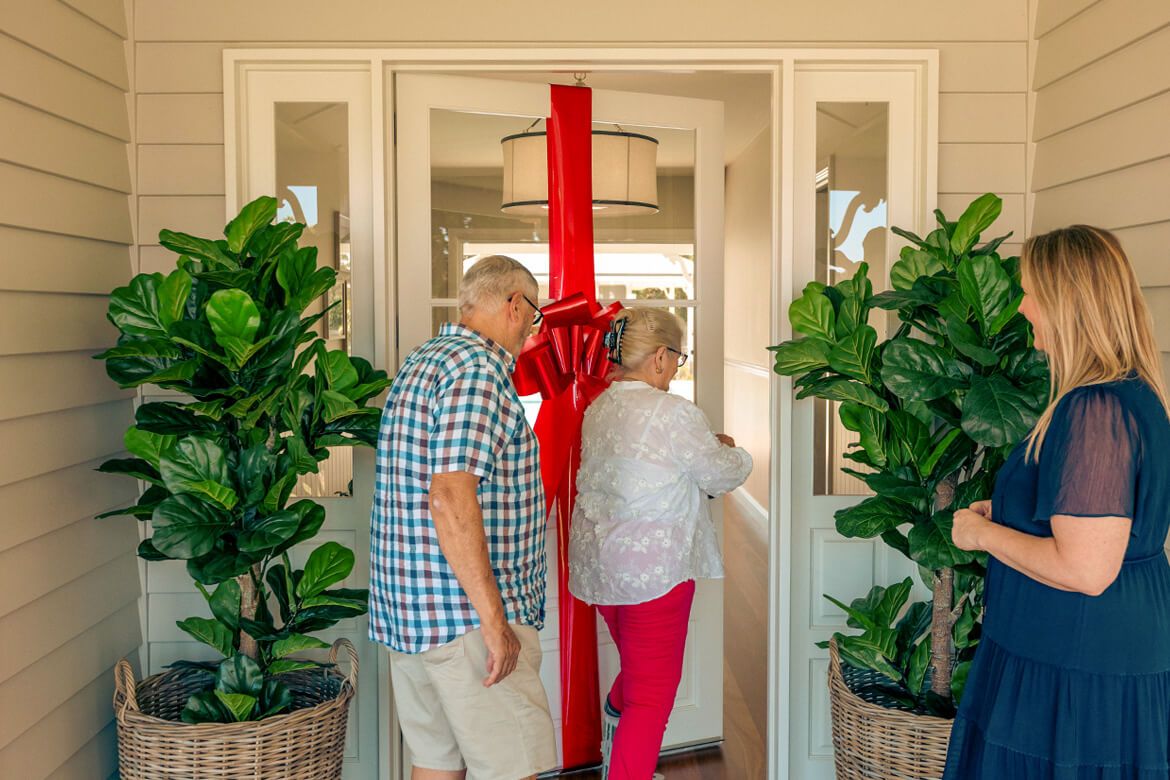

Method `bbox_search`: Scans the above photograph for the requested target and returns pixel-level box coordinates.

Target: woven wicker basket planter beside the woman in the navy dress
[828,642,952,780]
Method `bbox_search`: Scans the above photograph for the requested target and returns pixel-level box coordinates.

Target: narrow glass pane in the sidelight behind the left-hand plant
[275,103,353,498]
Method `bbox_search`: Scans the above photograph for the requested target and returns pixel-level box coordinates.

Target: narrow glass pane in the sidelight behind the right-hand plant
[812,103,889,496]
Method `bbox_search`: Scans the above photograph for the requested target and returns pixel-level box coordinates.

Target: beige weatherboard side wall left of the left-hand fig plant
[0,0,142,779]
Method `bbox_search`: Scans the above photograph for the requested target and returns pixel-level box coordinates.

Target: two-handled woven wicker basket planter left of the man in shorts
[113,640,358,780]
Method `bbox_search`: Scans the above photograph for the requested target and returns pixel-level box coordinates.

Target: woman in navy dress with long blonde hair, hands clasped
[944,225,1170,780]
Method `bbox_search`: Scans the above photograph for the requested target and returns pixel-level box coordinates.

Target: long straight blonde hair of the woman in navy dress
[1020,225,1170,460]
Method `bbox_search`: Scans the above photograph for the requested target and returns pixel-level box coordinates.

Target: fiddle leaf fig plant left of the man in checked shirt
[96,198,390,723]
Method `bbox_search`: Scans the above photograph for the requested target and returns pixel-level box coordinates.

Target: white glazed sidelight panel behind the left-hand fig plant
[227,63,385,780]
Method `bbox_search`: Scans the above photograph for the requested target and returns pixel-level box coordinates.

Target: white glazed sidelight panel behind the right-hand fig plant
[773,63,934,780]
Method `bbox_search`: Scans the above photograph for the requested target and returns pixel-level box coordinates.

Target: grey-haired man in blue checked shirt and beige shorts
[370,255,557,780]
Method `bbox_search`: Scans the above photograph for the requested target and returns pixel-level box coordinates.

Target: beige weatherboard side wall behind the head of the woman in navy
[1031,0,1170,378]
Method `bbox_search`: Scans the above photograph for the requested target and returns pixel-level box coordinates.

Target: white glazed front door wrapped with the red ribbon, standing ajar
[394,75,723,767]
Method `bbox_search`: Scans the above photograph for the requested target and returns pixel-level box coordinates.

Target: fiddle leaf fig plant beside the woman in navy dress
[771,193,1048,716]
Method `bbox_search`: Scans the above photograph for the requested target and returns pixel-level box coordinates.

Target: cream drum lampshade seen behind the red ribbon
[500,130,659,216]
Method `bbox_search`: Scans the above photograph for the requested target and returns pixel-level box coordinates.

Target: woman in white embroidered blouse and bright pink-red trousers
[569,308,751,780]
